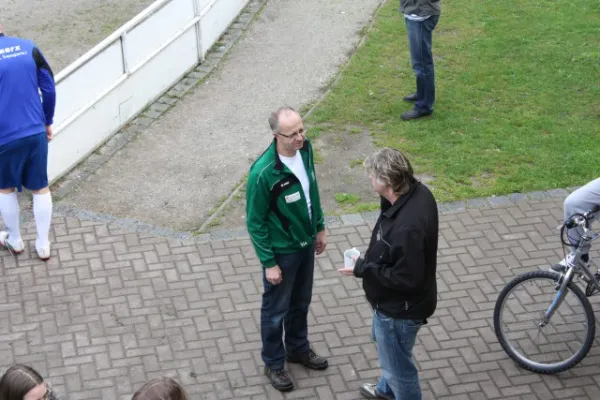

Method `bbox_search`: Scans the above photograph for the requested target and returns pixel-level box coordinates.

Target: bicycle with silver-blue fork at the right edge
[494,206,600,374]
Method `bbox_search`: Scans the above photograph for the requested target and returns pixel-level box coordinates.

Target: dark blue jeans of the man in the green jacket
[260,245,315,370]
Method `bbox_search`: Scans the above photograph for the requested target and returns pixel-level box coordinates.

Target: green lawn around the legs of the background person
[308,0,600,201]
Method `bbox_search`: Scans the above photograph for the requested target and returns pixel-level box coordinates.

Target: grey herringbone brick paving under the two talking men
[0,195,600,400]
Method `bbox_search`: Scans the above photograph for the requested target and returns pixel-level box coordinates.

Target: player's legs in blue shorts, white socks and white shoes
[0,132,52,260]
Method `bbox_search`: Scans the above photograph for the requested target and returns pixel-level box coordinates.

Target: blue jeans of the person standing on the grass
[405,15,440,112]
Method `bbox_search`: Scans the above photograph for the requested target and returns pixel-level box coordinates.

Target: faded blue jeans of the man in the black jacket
[373,311,423,400]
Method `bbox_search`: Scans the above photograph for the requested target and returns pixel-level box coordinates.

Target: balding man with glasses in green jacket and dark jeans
[246,107,328,391]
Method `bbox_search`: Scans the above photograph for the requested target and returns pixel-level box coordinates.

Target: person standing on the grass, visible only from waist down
[400,0,442,121]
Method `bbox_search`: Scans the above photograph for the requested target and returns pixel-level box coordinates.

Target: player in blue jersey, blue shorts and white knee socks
[0,26,56,261]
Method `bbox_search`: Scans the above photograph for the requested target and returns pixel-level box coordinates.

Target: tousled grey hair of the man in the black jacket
[363,147,414,195]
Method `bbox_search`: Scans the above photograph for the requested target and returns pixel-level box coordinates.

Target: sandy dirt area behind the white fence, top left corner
[0,0,154,73]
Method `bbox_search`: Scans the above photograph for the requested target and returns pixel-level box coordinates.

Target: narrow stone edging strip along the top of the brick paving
[44,187,577,243]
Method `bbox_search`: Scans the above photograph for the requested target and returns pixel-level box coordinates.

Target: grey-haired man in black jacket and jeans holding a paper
[339,148,439,400]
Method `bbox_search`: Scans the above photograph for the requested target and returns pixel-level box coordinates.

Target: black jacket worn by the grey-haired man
[354,181,439,319]
